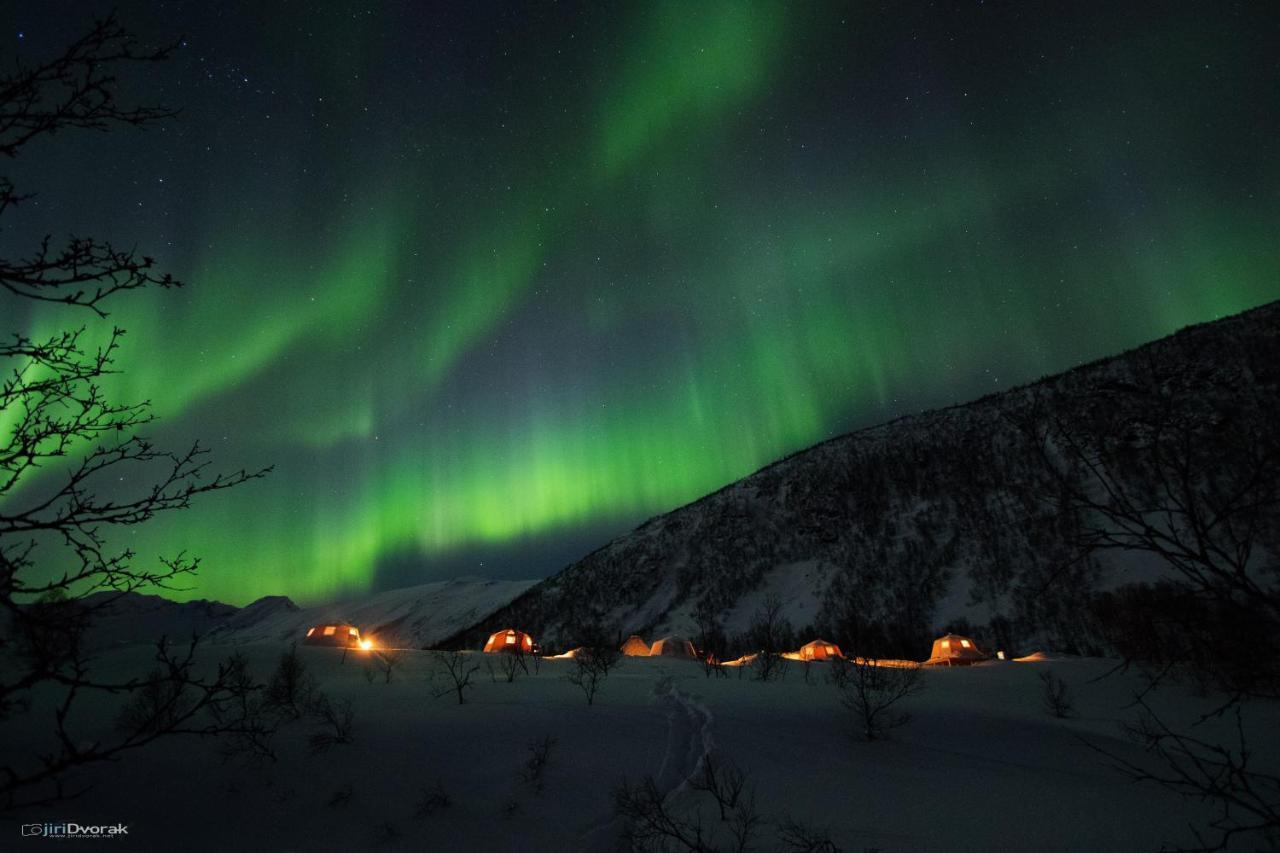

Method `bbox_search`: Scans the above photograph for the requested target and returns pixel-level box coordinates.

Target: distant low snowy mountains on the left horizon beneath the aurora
[78,578,535,648]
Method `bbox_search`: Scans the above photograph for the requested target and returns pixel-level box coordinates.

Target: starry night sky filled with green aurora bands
[0,0,1280,603]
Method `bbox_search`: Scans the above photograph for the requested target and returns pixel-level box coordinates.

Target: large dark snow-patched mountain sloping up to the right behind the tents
[448,302,1280,654]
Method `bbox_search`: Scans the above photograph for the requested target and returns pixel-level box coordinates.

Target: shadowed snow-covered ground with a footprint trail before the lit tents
[12,644,1277,853]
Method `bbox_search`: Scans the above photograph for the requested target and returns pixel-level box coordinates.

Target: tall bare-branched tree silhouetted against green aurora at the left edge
[0,17,265,808]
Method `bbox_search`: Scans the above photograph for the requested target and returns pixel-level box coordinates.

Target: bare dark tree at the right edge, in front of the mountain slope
[1018,353,1280,695]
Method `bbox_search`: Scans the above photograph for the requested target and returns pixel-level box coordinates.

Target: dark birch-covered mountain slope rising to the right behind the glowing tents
[447,302,1280,647]
